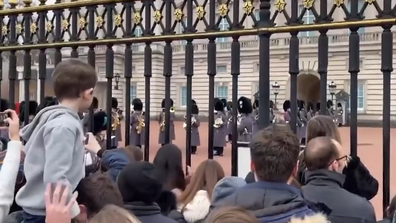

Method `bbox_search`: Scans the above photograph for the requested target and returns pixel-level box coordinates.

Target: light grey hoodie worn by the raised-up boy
[16,105,85,218]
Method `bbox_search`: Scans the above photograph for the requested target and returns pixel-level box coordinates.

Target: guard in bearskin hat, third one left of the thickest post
[183,103,201,154]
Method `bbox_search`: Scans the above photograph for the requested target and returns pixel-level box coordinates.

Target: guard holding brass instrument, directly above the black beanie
[129,98,146,148]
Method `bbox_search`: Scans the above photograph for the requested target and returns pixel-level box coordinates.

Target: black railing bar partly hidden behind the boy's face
[87,5,97,132]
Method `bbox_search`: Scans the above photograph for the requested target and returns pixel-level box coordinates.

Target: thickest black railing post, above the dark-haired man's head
[257,0,274,129]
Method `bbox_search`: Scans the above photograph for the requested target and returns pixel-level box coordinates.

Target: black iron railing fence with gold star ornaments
[0,0,396,212]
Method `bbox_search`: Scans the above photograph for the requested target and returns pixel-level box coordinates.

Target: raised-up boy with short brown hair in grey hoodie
[16,59,97,223]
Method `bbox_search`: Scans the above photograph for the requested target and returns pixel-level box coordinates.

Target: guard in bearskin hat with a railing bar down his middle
[157,99,175,145]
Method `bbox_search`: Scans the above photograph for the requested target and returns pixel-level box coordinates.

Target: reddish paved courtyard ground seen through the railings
[119,121,396,219]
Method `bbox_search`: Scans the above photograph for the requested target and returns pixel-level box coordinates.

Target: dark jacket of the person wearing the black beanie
[124,202,177,223]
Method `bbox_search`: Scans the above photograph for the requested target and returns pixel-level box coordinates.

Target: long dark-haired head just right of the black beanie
[153,144,186,191]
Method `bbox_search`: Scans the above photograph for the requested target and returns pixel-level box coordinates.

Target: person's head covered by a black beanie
[117,162,162,204]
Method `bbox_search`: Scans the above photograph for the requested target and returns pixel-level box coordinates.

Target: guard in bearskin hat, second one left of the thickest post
[213,98,227,156]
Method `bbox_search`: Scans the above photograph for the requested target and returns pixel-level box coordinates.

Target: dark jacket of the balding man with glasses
[301,170,376,223]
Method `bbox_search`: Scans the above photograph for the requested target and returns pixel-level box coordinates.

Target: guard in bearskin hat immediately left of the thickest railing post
[237,96,254,142]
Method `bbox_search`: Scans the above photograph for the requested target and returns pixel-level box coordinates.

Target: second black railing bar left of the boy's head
[23,3,31,125]
